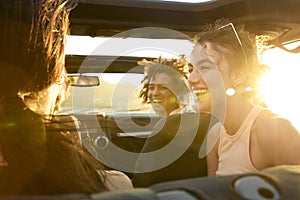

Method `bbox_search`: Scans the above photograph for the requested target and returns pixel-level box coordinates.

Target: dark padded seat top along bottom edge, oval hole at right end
[0,166,300,200]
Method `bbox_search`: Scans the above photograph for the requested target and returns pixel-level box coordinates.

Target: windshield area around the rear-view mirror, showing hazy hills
[60,73,150,114]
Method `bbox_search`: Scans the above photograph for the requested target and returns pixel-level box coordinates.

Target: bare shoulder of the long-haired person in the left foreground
[105,170,133,191]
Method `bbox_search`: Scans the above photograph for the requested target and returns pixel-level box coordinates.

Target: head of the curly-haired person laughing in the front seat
[139,56,197,117]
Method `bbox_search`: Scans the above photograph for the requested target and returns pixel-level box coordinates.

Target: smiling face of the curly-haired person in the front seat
[148,73,179,116]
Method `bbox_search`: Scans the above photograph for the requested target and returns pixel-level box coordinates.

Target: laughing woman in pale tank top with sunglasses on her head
[189,19,300,176]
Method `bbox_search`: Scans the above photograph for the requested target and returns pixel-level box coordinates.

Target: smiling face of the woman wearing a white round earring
[188,42,231,115]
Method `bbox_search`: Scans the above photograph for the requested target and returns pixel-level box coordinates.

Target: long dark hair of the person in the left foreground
[0,0,108,195]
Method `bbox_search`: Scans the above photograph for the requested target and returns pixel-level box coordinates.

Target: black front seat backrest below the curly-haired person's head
[133,113,217,187]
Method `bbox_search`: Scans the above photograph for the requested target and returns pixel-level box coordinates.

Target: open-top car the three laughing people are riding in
[0,0,300,200]
